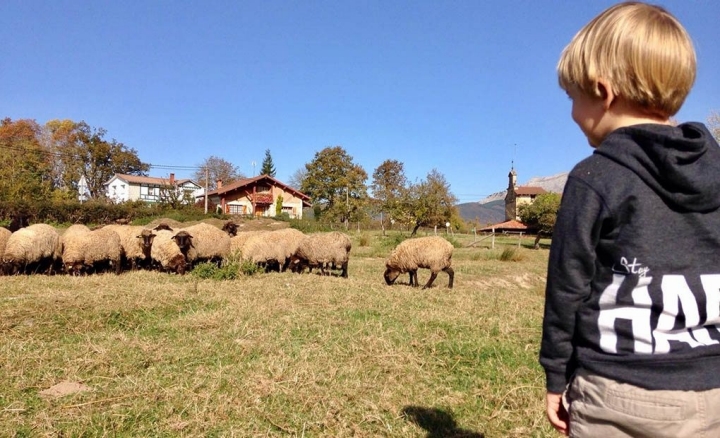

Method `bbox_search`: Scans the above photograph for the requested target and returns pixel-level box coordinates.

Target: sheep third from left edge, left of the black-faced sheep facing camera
[62,225,123,275]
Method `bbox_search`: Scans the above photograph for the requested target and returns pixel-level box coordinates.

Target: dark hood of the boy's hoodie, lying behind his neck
[595,123,720,212]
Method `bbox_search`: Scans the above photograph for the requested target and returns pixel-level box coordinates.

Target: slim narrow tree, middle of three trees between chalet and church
[370,160,407,230]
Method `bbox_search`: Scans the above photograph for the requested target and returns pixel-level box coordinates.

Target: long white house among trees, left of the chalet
[103,173,205,203]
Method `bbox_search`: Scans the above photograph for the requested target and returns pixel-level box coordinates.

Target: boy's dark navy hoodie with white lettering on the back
[540,123,720,393]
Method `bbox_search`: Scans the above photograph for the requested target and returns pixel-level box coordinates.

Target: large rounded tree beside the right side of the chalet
[300,146,367,226]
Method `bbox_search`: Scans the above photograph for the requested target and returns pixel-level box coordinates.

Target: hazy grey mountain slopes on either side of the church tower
[457,172,568,225]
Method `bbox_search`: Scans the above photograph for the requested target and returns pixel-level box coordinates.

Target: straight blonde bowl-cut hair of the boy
[557,2,696,118]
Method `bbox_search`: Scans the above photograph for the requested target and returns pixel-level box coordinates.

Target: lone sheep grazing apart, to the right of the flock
[384,236,455,289]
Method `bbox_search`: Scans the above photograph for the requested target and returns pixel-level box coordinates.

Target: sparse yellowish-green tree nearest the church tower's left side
[404,169,459,236]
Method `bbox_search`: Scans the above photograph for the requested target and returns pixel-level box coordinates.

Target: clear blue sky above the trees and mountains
[0,0,720,202]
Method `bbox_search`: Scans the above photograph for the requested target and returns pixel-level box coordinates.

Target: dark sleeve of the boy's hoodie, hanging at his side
[540,175,606,393]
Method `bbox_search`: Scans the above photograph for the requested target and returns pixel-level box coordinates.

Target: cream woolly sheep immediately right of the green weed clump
[242,228,305,272]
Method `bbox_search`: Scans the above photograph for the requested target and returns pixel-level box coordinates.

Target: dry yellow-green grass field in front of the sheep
[0,234,554,438]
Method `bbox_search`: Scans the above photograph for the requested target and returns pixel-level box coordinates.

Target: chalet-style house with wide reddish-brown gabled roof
[198,175,311,219]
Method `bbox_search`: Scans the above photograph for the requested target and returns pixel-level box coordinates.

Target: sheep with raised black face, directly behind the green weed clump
[175,222,230,265]
